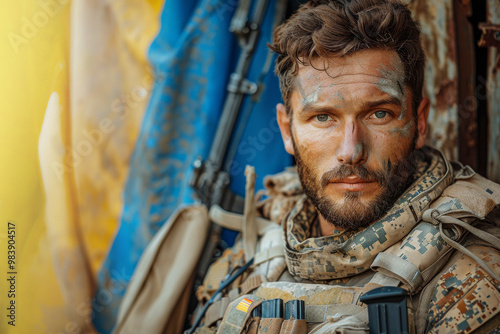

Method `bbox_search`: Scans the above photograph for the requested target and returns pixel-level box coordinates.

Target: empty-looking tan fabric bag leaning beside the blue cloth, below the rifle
[114,205,210,334]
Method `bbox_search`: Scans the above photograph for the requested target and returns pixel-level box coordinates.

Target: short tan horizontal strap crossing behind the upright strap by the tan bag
[208,205,279,236]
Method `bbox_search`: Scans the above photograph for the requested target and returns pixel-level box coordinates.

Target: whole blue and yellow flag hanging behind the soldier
[0,0,291,333]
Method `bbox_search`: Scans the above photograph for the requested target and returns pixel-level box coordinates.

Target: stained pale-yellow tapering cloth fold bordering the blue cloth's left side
[69,0,159,276]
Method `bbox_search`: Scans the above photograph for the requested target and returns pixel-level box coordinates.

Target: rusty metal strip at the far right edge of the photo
[486,0,500,182]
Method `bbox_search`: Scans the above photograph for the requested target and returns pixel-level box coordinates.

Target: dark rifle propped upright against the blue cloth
[190,0,269,326]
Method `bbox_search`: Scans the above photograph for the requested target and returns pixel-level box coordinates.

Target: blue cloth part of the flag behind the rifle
[92,0,291,333]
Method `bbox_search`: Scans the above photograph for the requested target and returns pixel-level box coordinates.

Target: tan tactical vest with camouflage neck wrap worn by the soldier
[197,148,500,334]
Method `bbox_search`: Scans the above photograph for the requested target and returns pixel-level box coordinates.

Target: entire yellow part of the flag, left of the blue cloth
[0,0,162,333]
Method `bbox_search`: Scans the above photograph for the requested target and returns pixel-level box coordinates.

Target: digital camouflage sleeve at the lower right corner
[425,245,500,334]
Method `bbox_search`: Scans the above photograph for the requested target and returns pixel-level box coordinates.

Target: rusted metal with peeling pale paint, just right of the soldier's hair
[406,0,459,160]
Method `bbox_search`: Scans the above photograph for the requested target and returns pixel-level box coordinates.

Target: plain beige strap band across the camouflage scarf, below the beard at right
[370,252,424,291]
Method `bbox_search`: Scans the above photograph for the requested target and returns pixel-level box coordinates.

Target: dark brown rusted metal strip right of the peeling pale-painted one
[453,1,479,171]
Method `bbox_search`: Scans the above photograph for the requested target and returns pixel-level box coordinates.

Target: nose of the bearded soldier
[337,121,366,165]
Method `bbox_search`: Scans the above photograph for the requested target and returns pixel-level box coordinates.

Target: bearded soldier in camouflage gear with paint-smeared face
[115,0,500,333]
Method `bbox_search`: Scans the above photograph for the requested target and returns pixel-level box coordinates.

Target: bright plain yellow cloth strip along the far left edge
[0,1,70,333]
